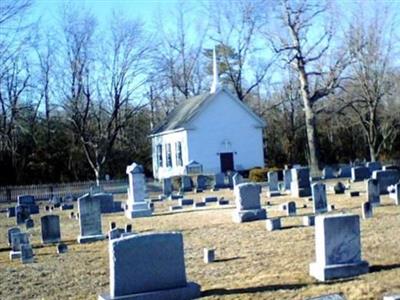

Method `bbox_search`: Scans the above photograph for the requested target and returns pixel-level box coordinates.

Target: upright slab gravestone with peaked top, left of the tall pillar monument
[78,194,104,243]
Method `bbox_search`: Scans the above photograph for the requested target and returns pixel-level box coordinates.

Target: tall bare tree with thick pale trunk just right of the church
[270,0,349,174]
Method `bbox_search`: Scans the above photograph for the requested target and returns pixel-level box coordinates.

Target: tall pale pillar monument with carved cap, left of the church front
[125,163,152,219]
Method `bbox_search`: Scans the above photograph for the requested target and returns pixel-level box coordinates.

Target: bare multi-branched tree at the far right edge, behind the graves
[339,10,400,161]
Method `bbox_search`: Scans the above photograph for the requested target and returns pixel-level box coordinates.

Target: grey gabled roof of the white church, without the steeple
[150,88,265,136]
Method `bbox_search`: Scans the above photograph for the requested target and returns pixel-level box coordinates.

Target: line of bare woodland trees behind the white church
[0,0,400,185]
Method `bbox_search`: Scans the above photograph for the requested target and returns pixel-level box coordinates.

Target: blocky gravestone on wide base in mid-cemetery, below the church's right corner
[232,183,267,223]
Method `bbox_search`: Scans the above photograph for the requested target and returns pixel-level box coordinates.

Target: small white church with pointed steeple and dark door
[150,51,265,179]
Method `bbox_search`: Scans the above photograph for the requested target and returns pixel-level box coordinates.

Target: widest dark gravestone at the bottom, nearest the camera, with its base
[98,232,200,300]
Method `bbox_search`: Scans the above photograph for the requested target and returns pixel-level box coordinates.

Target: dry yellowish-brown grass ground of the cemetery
[0,180,400,299]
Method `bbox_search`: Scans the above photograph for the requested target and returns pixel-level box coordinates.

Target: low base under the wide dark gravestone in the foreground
[97,282,200,300]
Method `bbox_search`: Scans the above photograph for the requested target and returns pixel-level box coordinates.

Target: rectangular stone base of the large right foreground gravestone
[310,261,369,281]
